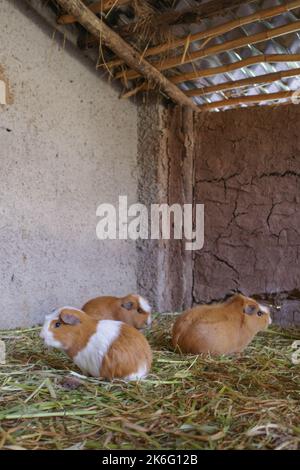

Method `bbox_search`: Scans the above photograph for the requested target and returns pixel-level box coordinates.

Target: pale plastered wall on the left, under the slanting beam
[0,0,137,328]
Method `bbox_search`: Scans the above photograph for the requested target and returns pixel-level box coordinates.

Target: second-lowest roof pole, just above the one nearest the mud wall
[184,68,300,96]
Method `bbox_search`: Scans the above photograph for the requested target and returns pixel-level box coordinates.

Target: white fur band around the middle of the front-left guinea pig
[73,320,122,377]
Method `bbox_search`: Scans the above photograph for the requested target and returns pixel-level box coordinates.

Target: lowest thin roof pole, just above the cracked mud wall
[198,91,295,111]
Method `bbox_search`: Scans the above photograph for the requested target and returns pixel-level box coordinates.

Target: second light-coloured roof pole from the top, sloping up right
[120,20,300,80]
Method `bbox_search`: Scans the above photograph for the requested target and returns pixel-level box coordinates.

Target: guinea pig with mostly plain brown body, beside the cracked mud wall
[172,294,271,354]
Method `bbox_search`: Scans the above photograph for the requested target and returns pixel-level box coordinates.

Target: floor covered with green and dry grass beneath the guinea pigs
[0,316,300,449]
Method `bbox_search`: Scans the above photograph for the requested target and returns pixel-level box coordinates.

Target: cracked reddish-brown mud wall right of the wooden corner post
[193,105,300,326]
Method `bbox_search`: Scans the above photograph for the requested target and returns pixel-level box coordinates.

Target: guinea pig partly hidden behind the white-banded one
[82,294,151,330]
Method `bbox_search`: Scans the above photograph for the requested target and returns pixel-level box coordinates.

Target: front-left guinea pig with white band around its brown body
[41,307,152,380]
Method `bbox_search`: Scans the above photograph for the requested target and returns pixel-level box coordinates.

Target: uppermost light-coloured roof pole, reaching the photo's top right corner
[107,0,300,68]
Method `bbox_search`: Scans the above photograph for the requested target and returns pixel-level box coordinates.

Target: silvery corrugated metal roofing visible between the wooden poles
[172,0,300,109]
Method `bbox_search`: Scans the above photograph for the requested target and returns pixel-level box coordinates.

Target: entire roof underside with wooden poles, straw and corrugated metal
[47,0,300,110]
